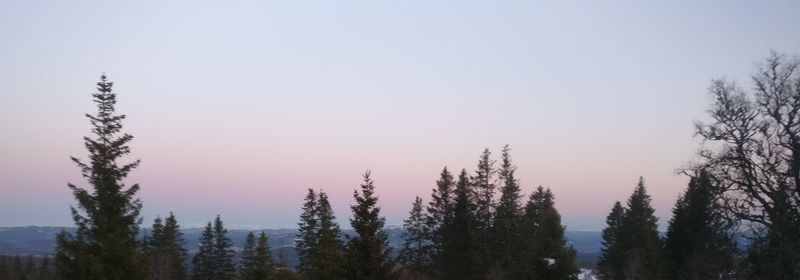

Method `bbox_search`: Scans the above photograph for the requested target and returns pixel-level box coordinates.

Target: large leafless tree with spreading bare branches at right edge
[697,52,800,279]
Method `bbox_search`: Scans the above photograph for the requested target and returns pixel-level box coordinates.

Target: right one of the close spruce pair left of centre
[310,191,344,280]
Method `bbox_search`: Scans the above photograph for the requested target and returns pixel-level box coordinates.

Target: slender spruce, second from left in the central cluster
[426,167,455,272]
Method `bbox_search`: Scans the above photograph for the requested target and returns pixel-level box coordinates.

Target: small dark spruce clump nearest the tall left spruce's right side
[146,213,186,280]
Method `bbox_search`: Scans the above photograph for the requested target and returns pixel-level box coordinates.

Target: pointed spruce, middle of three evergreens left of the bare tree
[617,178,663,280]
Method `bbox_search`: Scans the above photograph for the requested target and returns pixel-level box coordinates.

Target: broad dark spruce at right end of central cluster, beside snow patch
[522,186,580,280]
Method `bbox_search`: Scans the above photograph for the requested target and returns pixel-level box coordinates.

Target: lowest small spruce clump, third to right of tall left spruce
[240,231,276,280]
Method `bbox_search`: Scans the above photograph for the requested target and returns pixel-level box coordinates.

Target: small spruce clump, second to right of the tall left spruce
[192,216,236,280]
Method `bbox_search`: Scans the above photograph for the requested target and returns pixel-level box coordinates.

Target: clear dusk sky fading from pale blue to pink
[0,0,800,230]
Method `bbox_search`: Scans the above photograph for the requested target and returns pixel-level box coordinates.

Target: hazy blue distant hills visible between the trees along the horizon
[0,226,601,266]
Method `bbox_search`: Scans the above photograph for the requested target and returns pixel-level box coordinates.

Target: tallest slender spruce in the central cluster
[491,145,522,275]
